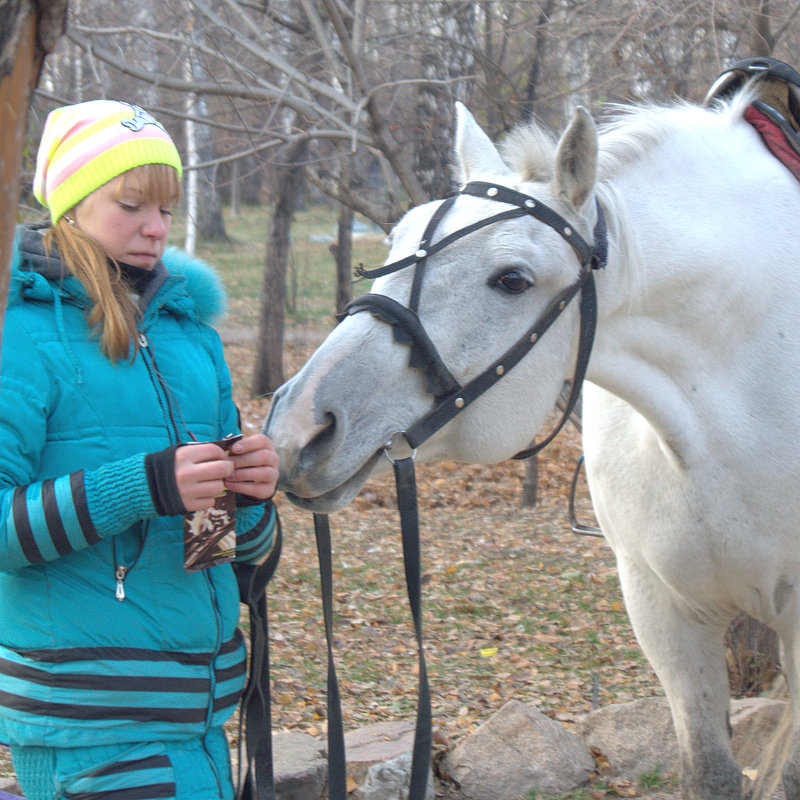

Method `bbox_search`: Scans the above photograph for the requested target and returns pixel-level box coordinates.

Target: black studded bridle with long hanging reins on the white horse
[314,181,608,800]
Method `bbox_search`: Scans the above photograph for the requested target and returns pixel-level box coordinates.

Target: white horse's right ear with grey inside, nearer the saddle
[553,106,597,211]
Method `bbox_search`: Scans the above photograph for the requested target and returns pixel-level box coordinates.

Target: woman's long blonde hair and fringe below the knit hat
[44,164,180,361]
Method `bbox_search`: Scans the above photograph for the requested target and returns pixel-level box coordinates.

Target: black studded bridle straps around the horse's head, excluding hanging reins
[346,181,608,458]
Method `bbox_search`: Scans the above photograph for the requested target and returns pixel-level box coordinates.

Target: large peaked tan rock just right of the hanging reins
[443,700,595,800]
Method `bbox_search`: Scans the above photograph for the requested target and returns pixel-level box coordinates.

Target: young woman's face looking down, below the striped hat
[72,175,172,269]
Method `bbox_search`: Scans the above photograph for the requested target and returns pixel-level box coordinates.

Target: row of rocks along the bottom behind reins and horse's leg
[0,697,788,800]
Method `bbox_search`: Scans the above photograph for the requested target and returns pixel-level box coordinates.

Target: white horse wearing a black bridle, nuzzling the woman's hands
[265,89,800,800]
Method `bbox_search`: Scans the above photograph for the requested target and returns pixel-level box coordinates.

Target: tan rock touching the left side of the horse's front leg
[578,697,679,781]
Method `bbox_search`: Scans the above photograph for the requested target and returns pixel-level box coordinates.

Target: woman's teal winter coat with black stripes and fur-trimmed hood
[0,228,275,747]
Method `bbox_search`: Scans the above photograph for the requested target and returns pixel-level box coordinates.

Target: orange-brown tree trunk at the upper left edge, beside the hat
[0,0,67,350]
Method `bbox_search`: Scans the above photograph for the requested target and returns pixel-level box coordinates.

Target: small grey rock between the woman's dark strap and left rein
[272,731,328,800]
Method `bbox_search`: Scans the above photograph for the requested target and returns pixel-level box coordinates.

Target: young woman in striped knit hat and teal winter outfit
[0,100,278,800]
